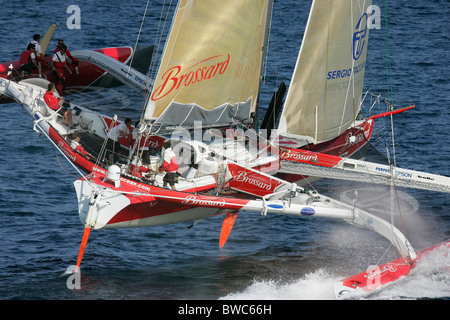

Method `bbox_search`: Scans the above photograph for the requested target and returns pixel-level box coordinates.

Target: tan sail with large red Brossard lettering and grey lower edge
[144,0,271,126]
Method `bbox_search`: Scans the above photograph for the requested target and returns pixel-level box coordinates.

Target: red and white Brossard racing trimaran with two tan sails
[0,0,450,297]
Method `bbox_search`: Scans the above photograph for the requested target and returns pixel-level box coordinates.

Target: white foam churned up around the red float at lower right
[220,244,450,300]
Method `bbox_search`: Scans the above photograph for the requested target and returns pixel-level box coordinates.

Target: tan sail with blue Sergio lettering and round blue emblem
[279,0,371,143]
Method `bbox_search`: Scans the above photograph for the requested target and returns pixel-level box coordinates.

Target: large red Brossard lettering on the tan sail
[152,54,230,101]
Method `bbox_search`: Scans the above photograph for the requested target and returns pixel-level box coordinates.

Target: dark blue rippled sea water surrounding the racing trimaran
[0,0,450,300]
